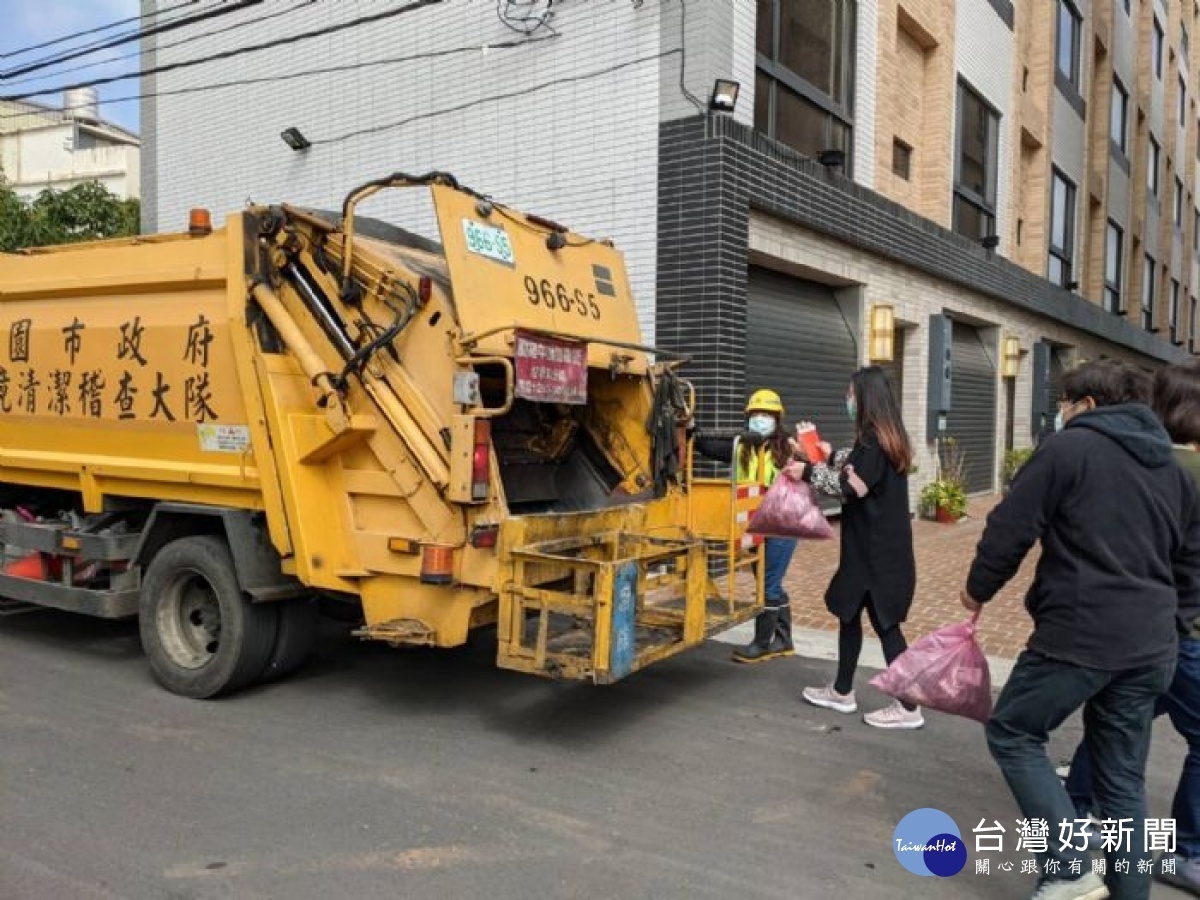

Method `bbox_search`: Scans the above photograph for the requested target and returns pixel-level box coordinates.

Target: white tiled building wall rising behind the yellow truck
[146,0,672,340]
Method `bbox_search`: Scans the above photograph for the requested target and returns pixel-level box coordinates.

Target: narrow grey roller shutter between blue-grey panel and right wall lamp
[947,322,996,493]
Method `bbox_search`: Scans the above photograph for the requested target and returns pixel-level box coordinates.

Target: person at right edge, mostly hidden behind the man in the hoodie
[1066,360,1200,896]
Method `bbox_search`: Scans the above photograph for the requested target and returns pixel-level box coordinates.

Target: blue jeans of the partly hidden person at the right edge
[1067,637,1200,859]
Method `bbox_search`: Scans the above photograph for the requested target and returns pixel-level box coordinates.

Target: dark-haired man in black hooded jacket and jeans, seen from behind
[961,360,1200,900]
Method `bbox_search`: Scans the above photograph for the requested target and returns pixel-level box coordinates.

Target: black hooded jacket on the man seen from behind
[967,403,1200,671]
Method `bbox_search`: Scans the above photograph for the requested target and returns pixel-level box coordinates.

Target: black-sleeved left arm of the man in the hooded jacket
[964,440,1079,605]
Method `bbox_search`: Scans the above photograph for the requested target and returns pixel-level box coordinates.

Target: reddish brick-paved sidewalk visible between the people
[785,494,1038,659]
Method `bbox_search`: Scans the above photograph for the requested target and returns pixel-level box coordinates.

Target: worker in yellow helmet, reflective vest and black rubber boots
[695,389,796,662]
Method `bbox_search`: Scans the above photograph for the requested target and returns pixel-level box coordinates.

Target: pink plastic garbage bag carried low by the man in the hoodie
[871,612,991,722]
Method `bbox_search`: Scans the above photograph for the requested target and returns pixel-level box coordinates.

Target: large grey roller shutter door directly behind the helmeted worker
[745,269,858,449]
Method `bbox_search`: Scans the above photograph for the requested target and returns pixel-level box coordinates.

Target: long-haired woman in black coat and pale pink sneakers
[803,366,924,728]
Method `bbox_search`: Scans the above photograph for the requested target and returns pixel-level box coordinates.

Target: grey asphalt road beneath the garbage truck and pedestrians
[0,612,1182,900]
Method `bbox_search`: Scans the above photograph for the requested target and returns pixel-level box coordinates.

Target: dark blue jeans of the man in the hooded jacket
[986,650,1175,900]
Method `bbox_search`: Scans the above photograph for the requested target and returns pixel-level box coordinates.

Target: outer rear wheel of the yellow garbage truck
[138,535,278,698]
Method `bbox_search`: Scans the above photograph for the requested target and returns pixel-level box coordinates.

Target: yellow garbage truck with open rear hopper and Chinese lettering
[0,173,762,697]
